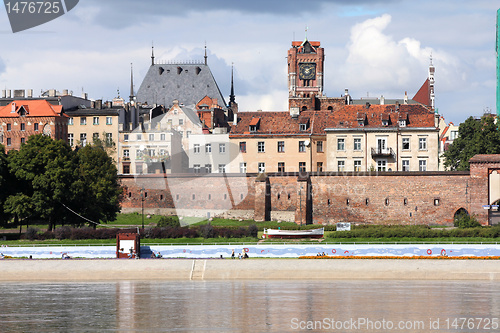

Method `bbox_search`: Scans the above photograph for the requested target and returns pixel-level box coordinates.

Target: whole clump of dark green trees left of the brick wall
[0,134,122,231]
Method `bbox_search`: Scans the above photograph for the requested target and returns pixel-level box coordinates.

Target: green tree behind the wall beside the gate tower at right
[444,116,500,171]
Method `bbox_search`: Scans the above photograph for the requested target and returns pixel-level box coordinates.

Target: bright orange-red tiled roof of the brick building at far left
[0,99,62,118]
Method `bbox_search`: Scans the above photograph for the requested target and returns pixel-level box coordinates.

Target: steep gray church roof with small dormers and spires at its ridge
[137,62,226,109]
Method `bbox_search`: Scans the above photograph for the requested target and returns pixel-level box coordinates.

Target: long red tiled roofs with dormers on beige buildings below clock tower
[230,104,435,137]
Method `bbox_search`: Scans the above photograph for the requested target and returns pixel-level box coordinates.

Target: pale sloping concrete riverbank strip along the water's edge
[0,259,500,282]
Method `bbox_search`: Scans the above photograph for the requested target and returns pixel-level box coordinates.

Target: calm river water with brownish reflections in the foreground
[0,280,500,332]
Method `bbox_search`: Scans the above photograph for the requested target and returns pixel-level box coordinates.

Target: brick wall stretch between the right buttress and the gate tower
[312,172,486,225]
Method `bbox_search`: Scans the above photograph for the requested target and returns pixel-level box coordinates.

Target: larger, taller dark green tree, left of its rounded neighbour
[7,134,75,230]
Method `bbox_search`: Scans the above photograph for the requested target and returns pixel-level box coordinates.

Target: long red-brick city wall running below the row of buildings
[121,157,492,225]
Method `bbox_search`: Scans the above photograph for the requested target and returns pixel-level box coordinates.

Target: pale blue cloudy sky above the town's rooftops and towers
[0,0,500,124]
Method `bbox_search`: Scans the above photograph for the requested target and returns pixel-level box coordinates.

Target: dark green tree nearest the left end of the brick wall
[73,141,123,227]
